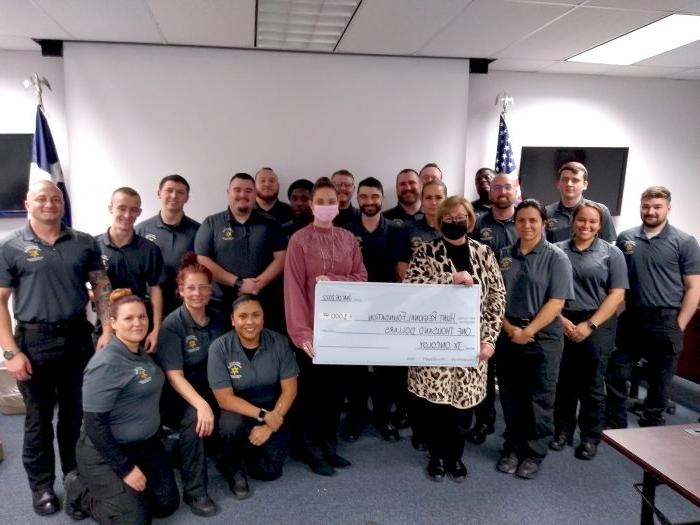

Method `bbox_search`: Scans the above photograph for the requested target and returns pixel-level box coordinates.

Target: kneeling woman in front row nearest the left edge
[64,288,180,525]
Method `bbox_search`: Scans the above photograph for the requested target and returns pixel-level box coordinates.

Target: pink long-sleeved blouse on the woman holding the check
[284,224,367,347]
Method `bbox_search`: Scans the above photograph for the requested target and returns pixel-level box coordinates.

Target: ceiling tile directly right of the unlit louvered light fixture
[337,0,471,55]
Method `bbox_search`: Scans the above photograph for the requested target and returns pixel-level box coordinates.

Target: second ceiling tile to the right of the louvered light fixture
[420,0,571,58]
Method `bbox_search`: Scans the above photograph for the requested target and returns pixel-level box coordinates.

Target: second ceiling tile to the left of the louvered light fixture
[33,0,163,43]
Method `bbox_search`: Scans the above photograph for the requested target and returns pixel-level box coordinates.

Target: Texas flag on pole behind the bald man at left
[29,106,72,227]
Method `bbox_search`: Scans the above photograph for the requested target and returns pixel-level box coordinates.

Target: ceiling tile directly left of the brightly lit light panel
[498,7,663,60]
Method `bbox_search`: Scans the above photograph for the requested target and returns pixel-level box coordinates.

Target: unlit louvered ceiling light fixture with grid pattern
[256,0,360,52]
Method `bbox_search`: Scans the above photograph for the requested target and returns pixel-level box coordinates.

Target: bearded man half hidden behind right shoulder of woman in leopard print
[466,174,518,445]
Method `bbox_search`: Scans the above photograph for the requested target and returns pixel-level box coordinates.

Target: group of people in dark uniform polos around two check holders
[0,162,700,523]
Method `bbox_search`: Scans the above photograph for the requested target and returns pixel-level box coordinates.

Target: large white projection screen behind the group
[64,43,469,229]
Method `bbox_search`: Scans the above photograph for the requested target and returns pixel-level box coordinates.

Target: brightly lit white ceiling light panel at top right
[567,15,700,66]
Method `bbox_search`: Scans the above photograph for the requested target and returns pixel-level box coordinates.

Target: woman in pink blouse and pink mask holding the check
[284,177,367,476]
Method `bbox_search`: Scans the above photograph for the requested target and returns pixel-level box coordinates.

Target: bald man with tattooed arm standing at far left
[0,181,111,517]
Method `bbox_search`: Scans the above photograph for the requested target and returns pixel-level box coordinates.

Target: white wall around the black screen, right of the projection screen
[466,71,700,237]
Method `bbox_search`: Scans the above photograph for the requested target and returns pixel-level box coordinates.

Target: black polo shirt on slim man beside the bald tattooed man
[96,230,165,299]
